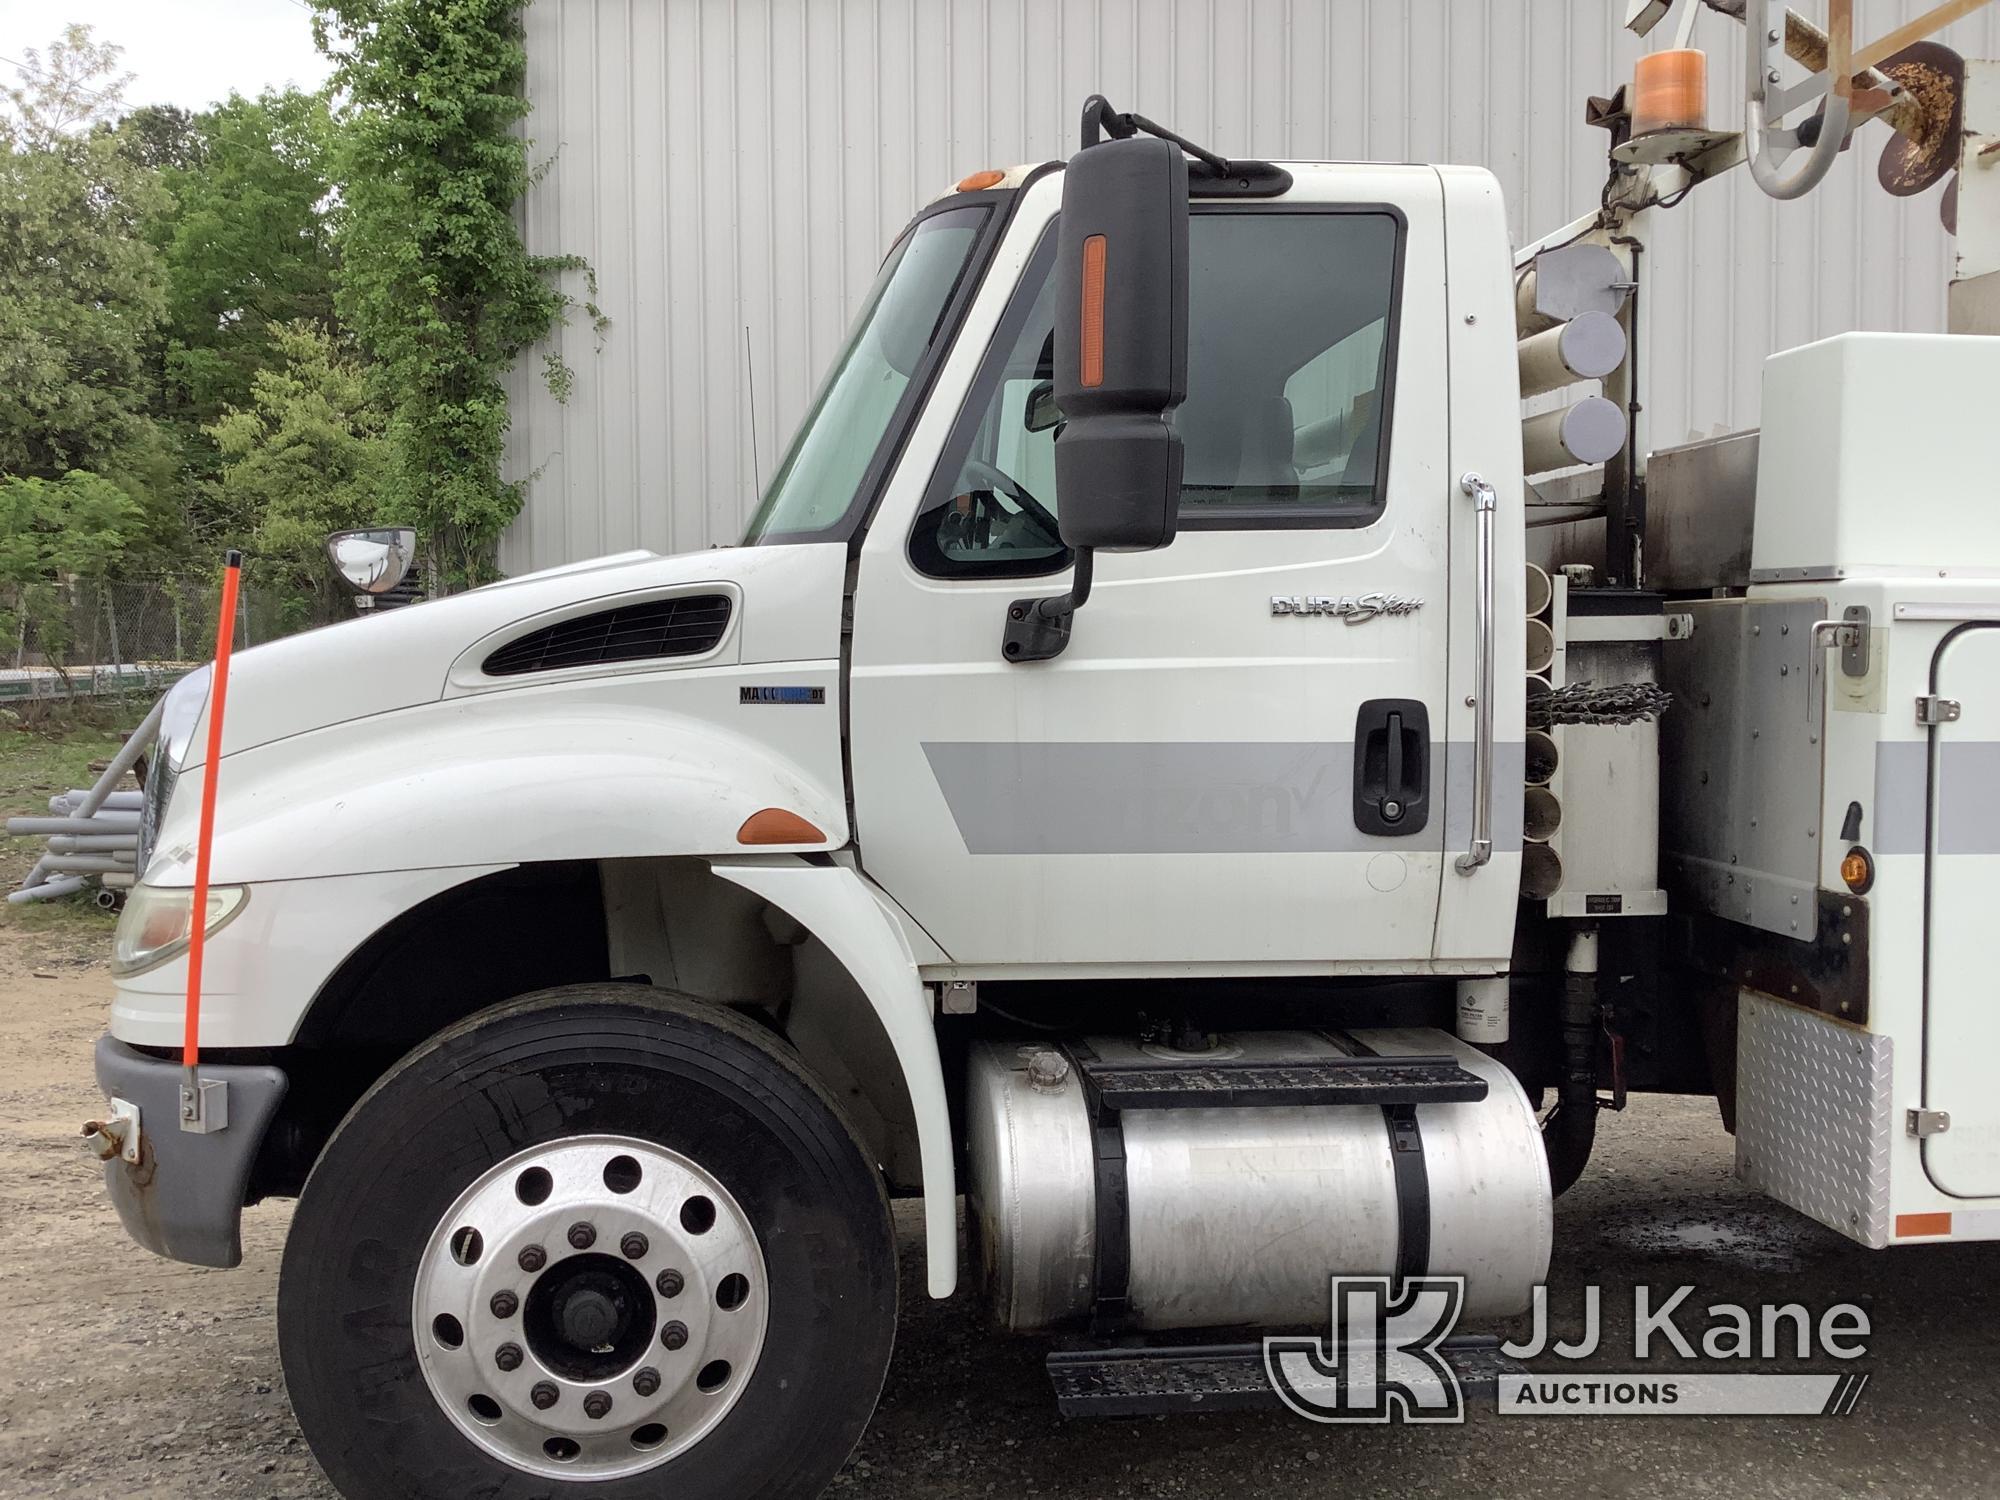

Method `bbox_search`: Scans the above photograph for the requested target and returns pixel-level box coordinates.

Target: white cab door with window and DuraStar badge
[850,166,1460,972]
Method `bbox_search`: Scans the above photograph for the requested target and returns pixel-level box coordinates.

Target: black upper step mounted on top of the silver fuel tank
[1074,1046,1486,1110]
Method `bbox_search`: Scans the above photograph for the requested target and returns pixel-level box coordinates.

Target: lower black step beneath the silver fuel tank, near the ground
[1048,1334,1526,1416]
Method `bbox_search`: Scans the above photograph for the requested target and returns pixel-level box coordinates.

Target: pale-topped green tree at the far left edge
[0,26,166,478]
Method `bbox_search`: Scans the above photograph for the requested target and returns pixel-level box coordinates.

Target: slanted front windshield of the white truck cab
[744,206,990,544]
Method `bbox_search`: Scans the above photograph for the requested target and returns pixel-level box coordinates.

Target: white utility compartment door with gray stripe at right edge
[1924,626,2000,1198]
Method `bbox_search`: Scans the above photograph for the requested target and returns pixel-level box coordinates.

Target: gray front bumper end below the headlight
[98,1036,288,1266]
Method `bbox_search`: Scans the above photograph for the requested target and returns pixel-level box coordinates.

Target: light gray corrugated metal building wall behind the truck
[502,0,2000,572]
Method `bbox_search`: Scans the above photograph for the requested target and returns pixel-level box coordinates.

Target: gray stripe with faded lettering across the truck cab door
[924,740,1524,854]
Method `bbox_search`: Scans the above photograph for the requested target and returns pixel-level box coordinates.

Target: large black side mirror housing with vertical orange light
[1064,136,1188,552]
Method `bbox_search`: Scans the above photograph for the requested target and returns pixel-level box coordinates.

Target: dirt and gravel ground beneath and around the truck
[0,928,2000,1500]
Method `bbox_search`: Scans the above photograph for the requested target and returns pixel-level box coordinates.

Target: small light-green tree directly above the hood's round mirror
[208,322,398,630]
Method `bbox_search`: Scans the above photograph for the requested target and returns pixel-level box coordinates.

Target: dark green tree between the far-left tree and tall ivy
[158,90,334,426]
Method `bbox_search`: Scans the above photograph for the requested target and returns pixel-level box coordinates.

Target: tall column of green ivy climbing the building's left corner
[314,0,578,582]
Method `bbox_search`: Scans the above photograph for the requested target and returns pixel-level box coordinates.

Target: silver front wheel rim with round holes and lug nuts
[412,1136,770,1480]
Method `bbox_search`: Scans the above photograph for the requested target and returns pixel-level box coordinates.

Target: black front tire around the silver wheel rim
[278,984,896,1500]
